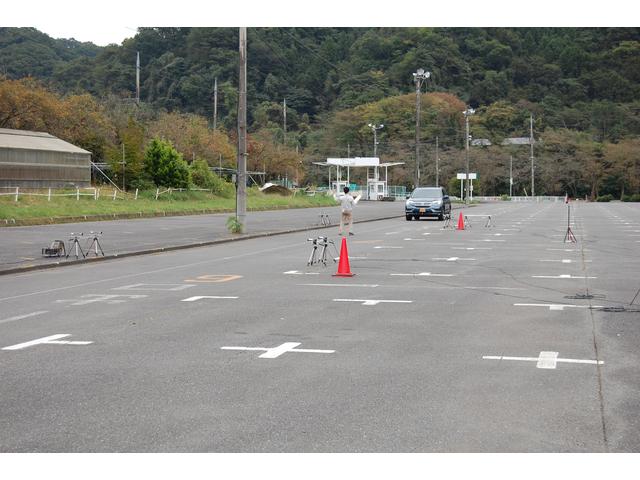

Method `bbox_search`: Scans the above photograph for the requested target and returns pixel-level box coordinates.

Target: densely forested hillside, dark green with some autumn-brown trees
[0,28,640,197]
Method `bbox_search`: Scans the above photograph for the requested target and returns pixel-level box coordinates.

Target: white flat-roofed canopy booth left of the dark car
[313,157,404,200]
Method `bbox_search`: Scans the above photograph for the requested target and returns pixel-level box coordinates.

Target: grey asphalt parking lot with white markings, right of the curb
[0,202,640,452]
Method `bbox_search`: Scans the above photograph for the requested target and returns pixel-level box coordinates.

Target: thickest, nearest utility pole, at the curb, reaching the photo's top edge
[236,27,247,233]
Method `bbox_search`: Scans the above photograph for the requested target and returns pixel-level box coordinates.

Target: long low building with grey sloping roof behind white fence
[0,128,91,188]
